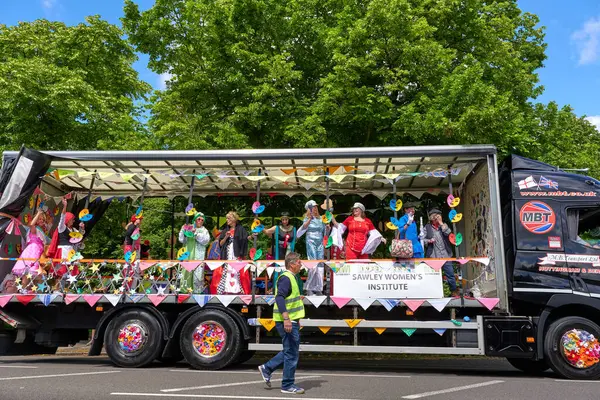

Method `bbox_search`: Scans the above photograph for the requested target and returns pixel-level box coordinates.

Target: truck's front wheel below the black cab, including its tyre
[544,317,600,380]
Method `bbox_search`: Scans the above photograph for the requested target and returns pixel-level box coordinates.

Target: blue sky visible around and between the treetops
[0,0,600,129]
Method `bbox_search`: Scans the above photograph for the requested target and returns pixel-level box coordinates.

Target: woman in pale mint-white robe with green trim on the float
[179,212,210,293]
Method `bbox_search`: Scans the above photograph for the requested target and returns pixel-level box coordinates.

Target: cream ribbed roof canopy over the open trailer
[3,145,496,197]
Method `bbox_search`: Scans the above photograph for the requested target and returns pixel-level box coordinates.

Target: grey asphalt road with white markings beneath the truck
[0,356,600,400]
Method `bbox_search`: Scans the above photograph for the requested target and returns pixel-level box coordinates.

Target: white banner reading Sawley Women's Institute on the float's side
[333,263,444,299]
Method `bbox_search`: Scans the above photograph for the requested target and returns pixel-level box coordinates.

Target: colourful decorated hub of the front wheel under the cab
[561,329,600,369]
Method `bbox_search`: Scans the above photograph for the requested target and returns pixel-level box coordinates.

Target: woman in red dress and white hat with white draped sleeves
[333,203,385,260]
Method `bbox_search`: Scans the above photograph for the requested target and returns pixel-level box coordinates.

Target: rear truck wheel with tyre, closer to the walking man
[179,310,242,369]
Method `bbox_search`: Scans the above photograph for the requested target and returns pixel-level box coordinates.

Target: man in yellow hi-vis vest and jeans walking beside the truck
[258,252,304,394]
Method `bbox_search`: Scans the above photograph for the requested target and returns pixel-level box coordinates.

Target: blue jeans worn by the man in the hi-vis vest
[263,322,300,389]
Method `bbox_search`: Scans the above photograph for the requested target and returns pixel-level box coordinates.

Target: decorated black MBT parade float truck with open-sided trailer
[0,145,600,379]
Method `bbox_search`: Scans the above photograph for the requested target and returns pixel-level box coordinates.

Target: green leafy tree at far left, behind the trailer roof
[0,16,152,150]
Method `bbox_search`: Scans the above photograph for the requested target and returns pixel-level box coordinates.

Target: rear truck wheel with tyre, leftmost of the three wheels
[104,310,164,368]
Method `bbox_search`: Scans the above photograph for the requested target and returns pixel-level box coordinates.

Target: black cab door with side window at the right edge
[564,204,600,297]
